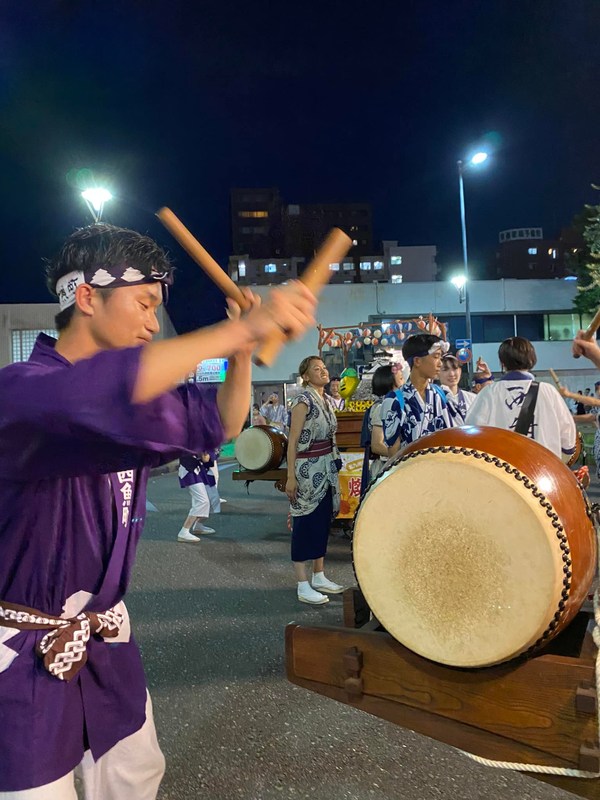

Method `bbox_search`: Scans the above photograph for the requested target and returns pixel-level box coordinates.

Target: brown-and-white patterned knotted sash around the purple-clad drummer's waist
[0,600,123,681]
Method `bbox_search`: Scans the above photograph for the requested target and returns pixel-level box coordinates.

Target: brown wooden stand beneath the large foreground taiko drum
[285,588,600,798]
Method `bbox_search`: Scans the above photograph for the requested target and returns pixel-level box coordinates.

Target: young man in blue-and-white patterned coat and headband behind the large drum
[381,333,453,455]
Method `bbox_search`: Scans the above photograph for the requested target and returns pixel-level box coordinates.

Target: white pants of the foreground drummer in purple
[0,695,165,800]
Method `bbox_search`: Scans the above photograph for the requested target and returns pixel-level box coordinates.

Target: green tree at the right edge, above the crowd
[567,191,600,314]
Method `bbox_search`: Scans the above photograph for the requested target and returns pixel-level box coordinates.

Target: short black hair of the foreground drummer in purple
[46,222,174,331]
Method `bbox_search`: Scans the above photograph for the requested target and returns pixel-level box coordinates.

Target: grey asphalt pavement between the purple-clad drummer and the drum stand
[128,467,592,800]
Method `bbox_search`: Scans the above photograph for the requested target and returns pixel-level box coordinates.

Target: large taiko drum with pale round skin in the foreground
[353,427,596,667]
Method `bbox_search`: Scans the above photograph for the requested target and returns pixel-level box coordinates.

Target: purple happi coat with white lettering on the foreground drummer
[0,334,223,792]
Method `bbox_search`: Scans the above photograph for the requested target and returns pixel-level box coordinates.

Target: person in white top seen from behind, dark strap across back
[465,336,577,460]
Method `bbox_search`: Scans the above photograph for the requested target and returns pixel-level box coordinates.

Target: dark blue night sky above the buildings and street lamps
[0,0,600,330]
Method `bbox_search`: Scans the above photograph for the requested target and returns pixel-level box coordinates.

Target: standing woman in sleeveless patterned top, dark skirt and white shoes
[285,356,344,605]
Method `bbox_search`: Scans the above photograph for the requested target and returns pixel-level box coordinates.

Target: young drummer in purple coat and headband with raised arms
[0,224,315,800]
